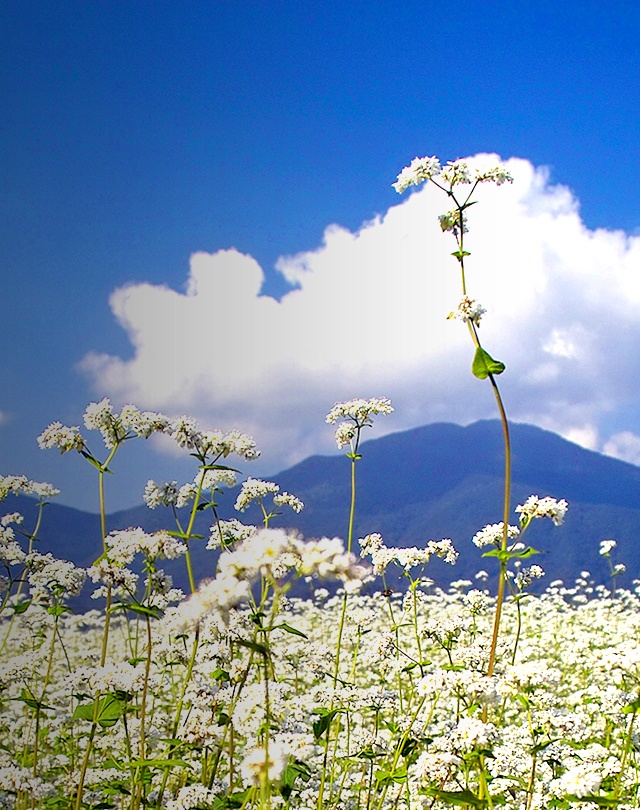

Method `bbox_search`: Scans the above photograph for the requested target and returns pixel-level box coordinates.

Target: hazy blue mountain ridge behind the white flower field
[10,420,640,600]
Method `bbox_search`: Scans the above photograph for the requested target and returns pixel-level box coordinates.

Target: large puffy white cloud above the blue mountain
[82,155,640,469]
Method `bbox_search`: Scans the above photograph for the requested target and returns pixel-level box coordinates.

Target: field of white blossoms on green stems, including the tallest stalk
[0,153,640,810]
